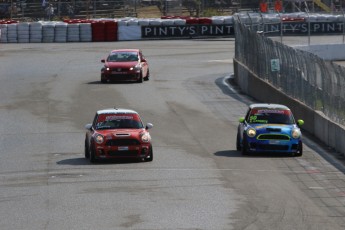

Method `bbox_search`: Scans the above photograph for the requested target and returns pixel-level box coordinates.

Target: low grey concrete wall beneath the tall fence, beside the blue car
[233,59,345,156]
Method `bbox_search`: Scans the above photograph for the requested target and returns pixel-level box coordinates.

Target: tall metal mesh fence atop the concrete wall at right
[234,19,345,125]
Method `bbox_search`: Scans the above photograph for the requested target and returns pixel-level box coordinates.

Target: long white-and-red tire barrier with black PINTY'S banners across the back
[0,13,345,43]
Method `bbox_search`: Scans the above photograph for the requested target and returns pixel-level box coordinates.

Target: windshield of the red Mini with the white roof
[96,115,144,130]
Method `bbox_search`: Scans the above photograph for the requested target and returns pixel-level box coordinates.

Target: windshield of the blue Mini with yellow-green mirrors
[247,110,295,125]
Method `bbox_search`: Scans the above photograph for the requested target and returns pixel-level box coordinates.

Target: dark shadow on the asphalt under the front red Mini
[56,157,146,165]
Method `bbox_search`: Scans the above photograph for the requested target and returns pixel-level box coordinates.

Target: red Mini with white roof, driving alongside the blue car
[85,108,153,163]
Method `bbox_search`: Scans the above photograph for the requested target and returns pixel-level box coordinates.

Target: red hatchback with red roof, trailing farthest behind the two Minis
[101,49,150,83]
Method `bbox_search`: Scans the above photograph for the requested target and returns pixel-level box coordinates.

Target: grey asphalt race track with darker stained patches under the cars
[0,38,345,230]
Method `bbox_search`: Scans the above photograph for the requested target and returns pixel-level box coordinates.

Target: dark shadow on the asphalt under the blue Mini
[214,150,294,158]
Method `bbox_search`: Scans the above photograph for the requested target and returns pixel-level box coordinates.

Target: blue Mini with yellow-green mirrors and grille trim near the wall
[236,103,304,156]
